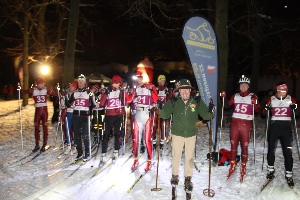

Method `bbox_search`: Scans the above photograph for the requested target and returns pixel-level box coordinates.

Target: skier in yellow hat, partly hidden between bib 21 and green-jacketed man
[153,75,172,149]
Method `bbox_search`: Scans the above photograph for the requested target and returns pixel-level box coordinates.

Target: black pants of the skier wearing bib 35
[73,115,90,155]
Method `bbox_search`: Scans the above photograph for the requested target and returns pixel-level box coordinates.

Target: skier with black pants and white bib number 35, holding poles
[66,74,96,162]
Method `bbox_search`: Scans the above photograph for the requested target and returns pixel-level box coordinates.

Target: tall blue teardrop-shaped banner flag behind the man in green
[182,16,218,150]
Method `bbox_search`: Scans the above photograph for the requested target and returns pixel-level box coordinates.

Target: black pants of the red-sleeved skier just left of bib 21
[102,115,122,153]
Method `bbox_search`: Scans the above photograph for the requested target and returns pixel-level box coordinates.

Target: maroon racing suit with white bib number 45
[228,91,260,164]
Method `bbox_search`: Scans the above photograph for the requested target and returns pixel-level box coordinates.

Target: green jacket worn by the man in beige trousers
[160,97,210,138]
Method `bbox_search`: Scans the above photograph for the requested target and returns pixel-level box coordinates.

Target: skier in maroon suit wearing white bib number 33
[22,77,57,152]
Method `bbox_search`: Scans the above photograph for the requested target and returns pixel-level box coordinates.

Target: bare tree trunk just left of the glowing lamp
[23,0,29,106]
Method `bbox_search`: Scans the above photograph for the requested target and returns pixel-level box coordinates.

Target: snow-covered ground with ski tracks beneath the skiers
[0,100,300,200]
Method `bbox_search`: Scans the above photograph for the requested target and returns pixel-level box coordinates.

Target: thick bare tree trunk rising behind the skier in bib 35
[62,0,80,85]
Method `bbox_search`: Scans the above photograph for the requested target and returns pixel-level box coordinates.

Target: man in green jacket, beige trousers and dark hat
[159,79,214,192]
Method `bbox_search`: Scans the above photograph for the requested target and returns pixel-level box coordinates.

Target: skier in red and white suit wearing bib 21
[126,71,158,171]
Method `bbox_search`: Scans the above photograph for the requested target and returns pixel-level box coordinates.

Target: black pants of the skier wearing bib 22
[267,121,293,171]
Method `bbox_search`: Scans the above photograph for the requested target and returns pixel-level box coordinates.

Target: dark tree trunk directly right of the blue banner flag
[215,0,228,91]
